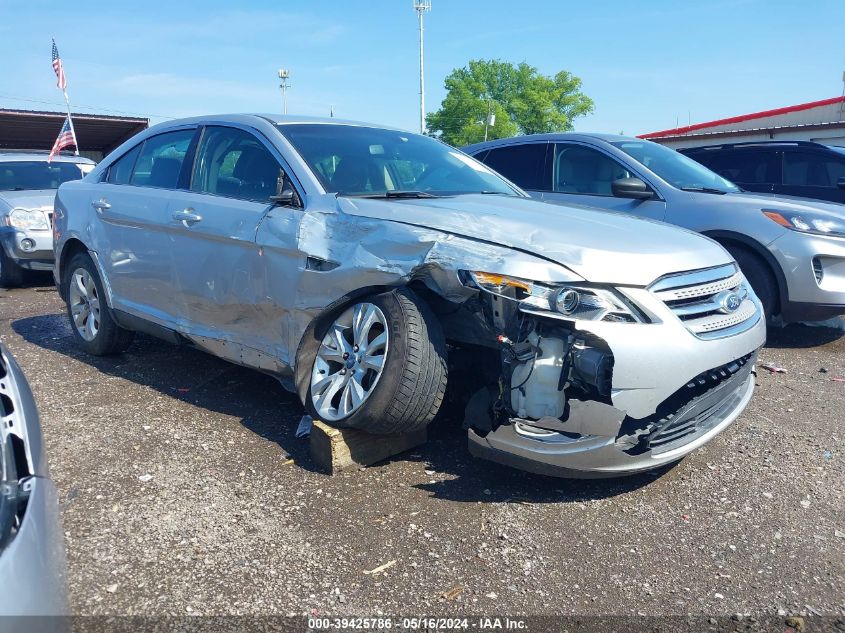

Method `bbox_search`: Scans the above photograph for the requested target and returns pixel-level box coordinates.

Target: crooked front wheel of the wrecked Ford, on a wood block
[300,289,447,435]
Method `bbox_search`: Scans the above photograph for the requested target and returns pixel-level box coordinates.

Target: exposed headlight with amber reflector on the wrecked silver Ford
[464,271,643,323]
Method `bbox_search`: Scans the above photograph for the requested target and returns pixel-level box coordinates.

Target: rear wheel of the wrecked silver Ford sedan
[62,253,135,356]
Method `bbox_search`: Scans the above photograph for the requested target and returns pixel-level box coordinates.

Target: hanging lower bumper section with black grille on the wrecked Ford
[469,352,757,478]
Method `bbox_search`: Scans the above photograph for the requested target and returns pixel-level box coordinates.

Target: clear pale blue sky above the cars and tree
[0,0,845,134]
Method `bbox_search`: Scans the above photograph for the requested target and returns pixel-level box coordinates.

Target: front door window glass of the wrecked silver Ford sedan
[191,126,282,202]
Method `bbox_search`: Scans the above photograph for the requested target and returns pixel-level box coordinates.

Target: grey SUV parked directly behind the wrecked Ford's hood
[464,133,845,321]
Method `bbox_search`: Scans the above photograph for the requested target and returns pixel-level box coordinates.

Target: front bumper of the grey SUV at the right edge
[769,231,845,321]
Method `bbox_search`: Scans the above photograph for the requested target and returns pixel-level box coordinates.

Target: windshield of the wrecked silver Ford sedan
[278,123,519,197]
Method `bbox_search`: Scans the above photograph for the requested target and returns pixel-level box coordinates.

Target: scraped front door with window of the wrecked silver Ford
[168,126,305,356]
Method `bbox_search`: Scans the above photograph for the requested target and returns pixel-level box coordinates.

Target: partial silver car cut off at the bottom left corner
[0,345,68,616]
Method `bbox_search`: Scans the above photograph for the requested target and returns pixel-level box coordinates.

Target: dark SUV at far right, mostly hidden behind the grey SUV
[678,141,845,203]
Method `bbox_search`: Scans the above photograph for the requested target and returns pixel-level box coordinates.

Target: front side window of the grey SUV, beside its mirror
[553,145,632,196]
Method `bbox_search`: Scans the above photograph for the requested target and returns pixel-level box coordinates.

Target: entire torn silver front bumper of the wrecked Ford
[469,288,766,478]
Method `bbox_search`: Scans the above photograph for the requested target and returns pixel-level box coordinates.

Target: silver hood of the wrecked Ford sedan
[338,194,732,286]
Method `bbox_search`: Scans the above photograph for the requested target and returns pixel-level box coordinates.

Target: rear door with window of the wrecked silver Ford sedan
[91,127,196,326]
